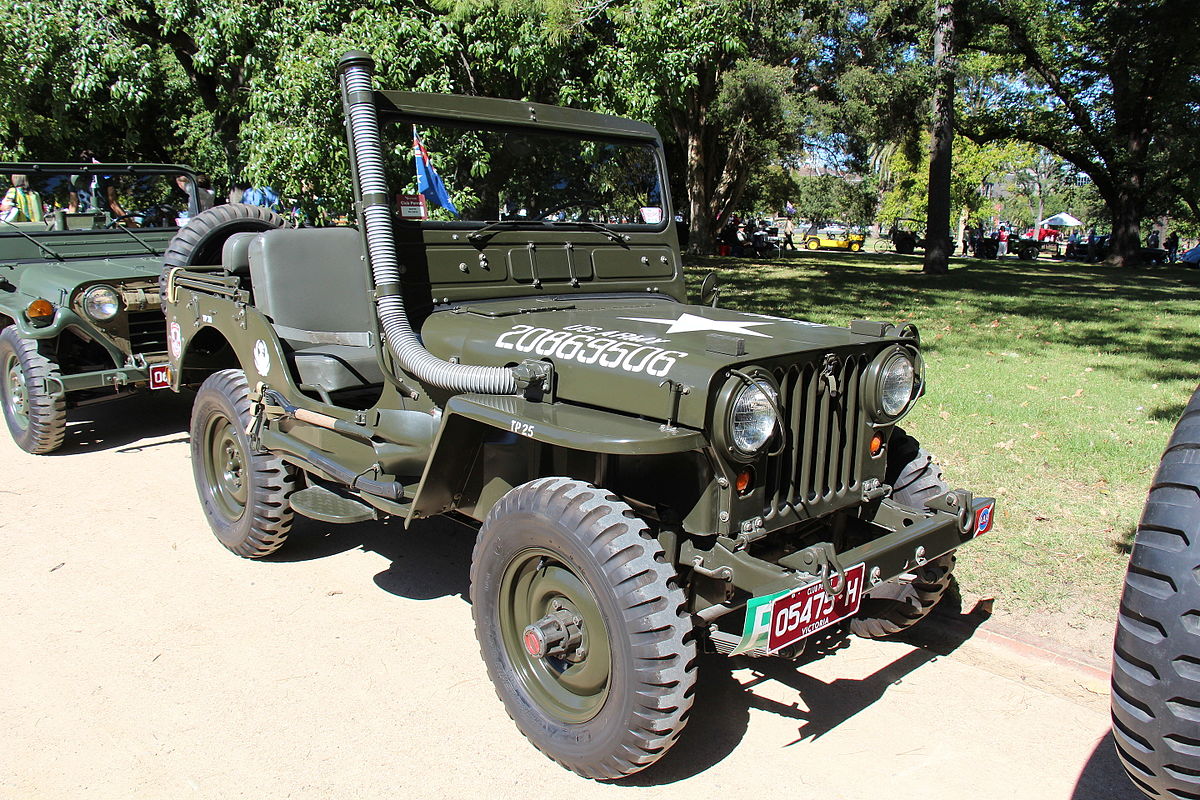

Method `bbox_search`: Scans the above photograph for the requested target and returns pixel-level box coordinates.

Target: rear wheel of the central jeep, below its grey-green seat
[191,369,296,559]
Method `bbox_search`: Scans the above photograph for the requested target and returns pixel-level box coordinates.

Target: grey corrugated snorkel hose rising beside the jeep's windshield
[338,52,517,395]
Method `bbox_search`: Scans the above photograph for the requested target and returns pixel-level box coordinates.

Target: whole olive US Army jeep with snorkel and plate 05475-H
[164,53,992,778]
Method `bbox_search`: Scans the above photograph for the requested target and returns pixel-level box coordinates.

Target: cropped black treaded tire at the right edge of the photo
[1112,387,1200,798]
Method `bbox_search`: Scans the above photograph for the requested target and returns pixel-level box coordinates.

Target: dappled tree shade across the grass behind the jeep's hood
[689,252,1200,383]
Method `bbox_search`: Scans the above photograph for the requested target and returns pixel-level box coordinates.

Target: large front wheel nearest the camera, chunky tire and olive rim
[470,477,696,780]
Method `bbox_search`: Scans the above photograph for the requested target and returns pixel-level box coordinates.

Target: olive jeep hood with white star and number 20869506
[421,296,898,428]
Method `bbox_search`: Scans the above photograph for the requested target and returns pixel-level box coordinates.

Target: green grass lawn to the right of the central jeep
[688,251,1200,649]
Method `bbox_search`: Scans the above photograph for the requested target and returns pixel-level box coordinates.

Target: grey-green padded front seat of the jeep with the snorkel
[241,228,383,392]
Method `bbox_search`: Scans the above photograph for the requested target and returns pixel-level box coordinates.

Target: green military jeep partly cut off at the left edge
[0,162,229,453]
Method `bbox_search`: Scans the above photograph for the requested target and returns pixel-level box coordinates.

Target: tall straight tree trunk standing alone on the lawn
[924,0,954,273]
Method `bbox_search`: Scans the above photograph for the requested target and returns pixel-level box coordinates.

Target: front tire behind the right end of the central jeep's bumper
[850,428,954,639]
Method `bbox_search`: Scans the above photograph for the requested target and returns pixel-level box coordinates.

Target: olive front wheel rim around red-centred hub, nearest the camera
[498,547,612,724]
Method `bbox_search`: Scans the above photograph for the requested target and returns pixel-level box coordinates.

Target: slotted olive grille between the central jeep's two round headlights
[763,354,869,519]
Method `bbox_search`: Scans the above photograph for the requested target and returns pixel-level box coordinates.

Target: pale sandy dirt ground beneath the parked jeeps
[0,396,1140,800]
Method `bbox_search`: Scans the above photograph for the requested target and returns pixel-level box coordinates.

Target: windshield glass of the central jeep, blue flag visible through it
[389,124,666,227]
